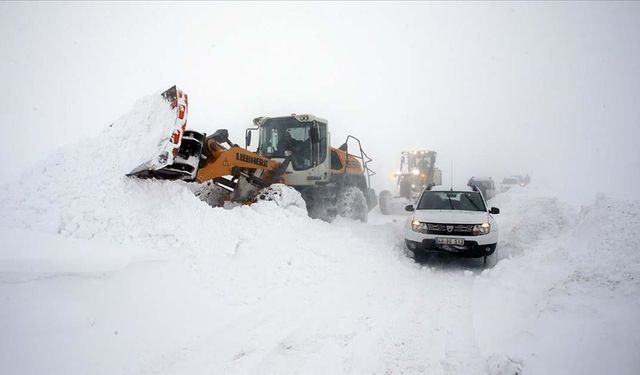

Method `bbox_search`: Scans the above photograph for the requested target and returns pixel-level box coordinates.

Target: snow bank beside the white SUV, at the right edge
[474,191,640,374]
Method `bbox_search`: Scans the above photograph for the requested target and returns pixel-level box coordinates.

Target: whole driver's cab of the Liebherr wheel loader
[254,115,330,185]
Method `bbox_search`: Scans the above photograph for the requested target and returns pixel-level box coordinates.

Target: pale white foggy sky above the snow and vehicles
[0,2,640,203]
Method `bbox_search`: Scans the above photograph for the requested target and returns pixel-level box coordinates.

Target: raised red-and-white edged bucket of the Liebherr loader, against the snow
[127,86,204,181]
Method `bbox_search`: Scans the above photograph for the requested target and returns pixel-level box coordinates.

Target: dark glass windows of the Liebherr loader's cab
[258,117,327,170]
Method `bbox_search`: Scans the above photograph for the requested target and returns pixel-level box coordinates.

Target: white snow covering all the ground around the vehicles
[0,93,640,375]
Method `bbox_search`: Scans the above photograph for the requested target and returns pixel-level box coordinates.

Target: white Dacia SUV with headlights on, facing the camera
[404,186,500,261]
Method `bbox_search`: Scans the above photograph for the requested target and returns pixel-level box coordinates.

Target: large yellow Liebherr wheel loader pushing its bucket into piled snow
[127,86,377,221]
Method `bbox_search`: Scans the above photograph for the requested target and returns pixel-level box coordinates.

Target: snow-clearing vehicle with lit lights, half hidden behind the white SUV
[379,150,442,215]
